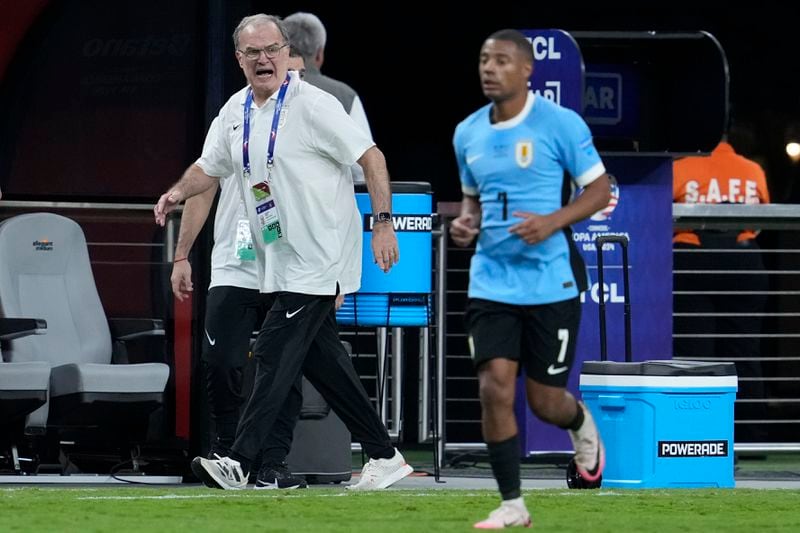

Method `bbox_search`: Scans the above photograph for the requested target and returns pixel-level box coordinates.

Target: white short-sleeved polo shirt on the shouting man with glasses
[196,72,375,295]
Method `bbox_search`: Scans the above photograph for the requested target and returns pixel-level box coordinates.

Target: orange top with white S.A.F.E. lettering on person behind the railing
[672,141,769,246]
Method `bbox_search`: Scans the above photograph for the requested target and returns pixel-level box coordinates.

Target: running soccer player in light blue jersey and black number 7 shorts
[450,30,610,529]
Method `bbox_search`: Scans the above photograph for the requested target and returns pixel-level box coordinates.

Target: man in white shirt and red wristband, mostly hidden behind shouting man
[171,117,307,489]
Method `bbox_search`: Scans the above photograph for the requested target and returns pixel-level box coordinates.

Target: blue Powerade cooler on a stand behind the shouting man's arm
[336,182,433,327]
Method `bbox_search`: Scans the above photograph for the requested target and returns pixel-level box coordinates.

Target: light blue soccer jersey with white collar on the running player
[453,92,605,305]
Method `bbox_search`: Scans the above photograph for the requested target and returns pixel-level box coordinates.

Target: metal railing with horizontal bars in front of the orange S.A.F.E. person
[673,204,800,452]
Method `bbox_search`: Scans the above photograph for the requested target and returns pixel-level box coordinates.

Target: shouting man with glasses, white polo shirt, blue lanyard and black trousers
[154,15,412,490]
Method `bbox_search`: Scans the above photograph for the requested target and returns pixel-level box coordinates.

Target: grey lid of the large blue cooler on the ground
[581,359,736,376]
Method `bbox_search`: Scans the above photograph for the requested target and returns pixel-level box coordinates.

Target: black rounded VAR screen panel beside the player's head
[570,31,730,155]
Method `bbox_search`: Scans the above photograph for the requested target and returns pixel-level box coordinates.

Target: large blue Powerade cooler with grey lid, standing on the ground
[580,360,737,488]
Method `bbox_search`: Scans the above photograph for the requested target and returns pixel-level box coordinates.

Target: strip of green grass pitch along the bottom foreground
[0,486,800,533]
